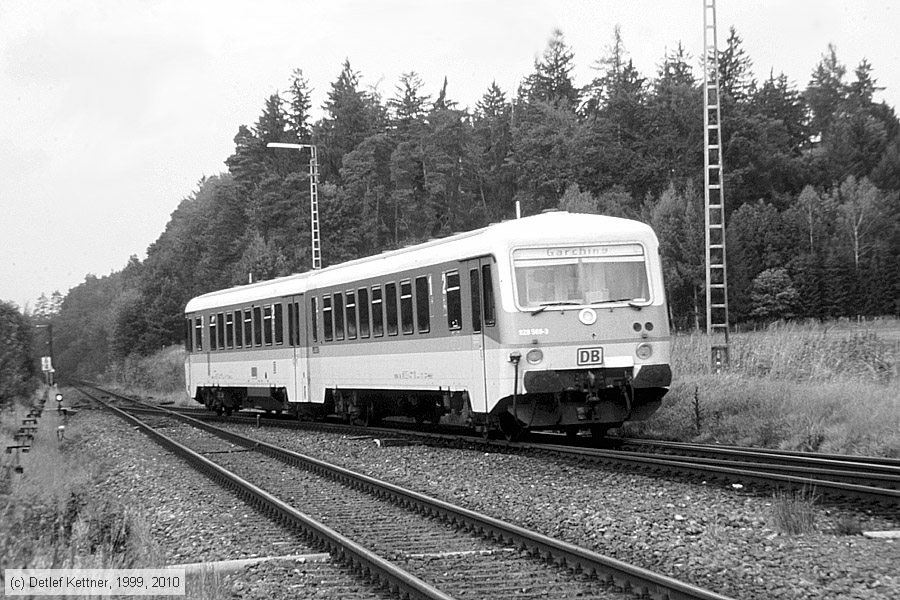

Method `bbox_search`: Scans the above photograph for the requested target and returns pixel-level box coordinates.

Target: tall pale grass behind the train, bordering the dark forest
[106,319,900,457]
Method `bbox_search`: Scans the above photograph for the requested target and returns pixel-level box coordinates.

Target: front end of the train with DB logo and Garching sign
[492,213,672,435]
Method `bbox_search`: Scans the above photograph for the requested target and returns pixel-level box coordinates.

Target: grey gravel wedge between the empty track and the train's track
[220,426,900,600]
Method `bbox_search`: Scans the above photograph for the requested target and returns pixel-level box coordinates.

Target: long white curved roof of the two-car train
[185,211,657,313]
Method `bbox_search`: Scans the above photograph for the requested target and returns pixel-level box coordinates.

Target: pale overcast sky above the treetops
[0,0,900,307]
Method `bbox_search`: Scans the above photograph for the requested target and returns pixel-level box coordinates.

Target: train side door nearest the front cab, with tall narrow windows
[463,256,494,413]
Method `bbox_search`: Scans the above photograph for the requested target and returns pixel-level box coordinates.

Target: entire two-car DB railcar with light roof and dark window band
[185,212,672,436]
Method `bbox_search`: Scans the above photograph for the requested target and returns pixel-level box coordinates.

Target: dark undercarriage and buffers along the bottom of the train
[195,365,671,440]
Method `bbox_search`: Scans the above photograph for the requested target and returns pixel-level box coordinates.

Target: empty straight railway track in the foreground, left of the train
[82,390,736,600]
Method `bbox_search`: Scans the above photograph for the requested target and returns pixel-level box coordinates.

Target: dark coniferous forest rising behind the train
[44,28,900,375]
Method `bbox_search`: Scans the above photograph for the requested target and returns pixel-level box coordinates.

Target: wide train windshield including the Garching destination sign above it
[513,244,650,309]
